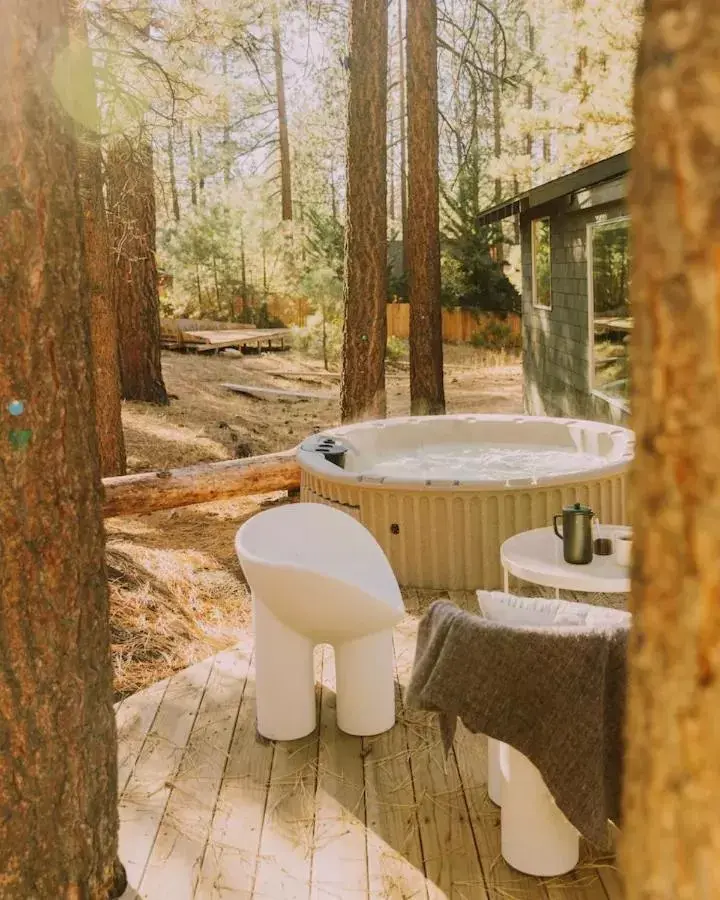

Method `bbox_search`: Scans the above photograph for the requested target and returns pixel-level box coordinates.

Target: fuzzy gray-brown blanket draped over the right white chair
[407,600,629,846]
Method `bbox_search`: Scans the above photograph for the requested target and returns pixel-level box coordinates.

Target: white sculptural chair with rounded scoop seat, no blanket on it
[235,503,405,740]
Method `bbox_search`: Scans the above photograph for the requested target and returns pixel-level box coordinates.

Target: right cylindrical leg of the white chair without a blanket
[335,630,395,736]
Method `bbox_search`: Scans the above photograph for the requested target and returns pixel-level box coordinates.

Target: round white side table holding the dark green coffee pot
[500,525,630,597]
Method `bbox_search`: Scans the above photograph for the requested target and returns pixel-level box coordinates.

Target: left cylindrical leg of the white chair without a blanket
[253,596,316,741]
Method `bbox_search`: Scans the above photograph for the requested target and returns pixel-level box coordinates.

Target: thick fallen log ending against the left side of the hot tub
[103,450,300,518]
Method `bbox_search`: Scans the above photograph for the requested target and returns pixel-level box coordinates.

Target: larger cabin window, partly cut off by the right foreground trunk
[587,217,633,409]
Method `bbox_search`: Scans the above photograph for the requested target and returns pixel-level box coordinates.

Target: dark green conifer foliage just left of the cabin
[441,180,521,313]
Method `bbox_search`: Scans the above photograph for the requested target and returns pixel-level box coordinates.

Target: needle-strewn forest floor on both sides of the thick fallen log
[106,345,522,697]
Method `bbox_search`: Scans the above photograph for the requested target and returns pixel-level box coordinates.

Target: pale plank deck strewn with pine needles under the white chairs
[117,591,623,900]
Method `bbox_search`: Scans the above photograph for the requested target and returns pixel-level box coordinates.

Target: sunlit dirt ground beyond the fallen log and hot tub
[123,345,522,472]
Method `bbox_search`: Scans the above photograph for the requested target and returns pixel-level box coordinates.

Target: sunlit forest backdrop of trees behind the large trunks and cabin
[87,0,641,329]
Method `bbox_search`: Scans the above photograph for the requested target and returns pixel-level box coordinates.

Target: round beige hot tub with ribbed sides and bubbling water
[298,415,634,590]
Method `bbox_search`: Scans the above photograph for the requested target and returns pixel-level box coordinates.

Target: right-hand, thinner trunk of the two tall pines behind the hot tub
[407,0,445,415]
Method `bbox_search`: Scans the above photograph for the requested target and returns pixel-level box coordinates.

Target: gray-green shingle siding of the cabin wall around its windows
[520,198,628,423]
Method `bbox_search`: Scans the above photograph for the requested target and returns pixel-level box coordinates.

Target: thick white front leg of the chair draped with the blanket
[499,744,580,878]
